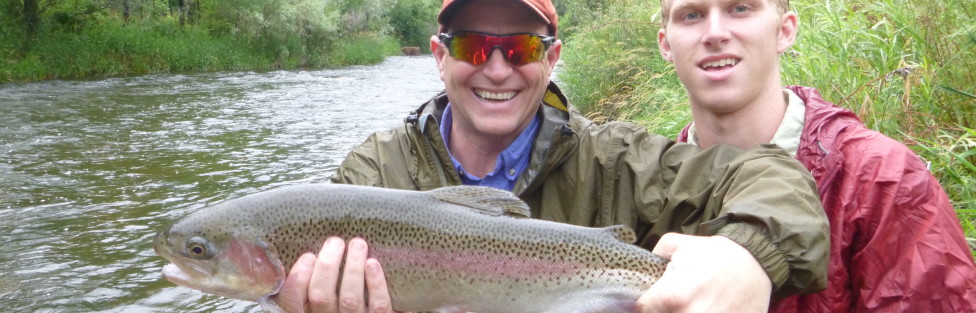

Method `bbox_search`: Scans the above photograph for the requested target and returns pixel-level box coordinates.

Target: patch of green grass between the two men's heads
[558,0,691,134]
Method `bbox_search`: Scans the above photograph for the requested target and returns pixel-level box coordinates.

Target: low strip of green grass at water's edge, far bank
[0,17,399,83]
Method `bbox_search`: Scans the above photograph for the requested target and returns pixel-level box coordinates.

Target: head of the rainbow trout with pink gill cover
[153,217,285,301]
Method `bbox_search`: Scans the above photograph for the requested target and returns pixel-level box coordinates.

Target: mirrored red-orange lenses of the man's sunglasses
[447,32,546,65]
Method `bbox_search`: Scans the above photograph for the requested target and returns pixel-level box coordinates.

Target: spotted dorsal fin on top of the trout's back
[428,186,531,218]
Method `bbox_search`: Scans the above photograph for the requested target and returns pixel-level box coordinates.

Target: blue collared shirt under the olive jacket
[441,103,539,191]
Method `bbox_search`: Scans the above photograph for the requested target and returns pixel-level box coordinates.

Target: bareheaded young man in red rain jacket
[658,0,976,312]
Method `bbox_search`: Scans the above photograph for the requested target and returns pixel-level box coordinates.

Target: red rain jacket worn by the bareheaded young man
[678,87,976,313]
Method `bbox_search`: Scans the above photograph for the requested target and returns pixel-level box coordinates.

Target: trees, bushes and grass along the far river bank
[0,0,440,82]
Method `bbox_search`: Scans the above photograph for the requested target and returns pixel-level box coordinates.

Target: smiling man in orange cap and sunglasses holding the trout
[278,0,828,312]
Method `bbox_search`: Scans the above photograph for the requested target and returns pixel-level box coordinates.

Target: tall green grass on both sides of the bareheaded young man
[557,0,976,255]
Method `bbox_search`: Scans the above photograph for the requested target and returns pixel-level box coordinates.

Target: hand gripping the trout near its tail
[638,233,772,313]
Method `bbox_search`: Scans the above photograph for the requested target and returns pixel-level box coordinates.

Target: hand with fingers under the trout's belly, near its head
[275,237,394,313]
